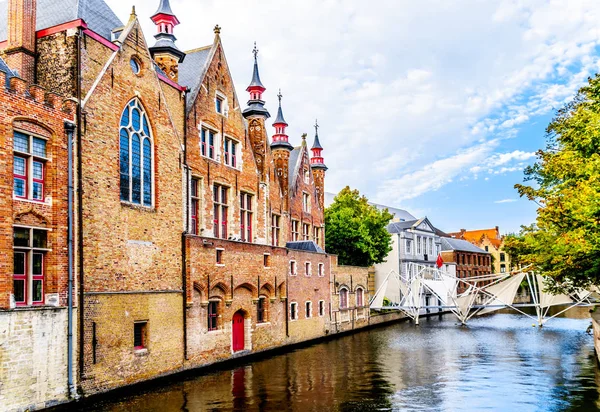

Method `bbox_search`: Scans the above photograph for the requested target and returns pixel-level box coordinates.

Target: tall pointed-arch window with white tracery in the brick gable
[119,99,153,206]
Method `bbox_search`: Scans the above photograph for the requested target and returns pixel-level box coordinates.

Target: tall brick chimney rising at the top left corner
[4,0,37,83]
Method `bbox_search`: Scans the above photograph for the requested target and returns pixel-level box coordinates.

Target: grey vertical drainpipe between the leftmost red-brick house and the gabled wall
[65,122,77,398]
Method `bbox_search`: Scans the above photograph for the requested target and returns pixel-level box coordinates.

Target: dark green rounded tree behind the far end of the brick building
[325,187,393,266]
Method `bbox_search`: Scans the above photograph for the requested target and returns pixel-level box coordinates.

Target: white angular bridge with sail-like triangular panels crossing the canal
[370,263,591,326]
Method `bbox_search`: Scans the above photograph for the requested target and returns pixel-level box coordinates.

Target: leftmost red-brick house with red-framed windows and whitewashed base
[0,37,75,410]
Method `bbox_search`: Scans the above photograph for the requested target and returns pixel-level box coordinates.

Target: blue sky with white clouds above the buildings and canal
[106,0,600,233]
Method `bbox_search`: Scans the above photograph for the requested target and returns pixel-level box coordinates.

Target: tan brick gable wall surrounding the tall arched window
[81,22,184,394]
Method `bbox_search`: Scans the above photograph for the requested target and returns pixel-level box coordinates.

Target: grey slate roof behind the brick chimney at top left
[0,0,123,41]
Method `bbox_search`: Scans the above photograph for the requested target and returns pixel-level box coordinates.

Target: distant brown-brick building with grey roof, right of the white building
[442,237,491,293]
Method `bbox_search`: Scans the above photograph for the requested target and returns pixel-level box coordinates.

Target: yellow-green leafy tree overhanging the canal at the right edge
[512,75,600,291]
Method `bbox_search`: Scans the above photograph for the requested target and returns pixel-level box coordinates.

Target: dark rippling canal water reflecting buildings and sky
[72,308,600,412]
